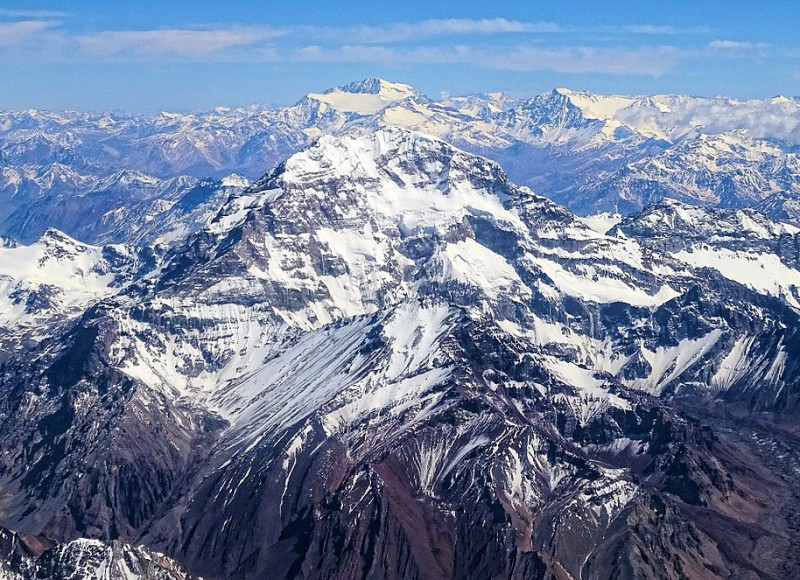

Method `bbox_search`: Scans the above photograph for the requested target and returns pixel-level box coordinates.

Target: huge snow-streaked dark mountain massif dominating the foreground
[0,128,800,578]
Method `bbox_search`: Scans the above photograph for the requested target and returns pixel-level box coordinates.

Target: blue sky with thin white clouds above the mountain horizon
[0,0,800,111]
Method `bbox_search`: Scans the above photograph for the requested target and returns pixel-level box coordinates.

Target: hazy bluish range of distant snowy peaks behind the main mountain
[0,78,800,243]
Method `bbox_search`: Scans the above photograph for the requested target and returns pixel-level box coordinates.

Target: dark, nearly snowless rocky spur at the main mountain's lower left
[0,310,224,541]
